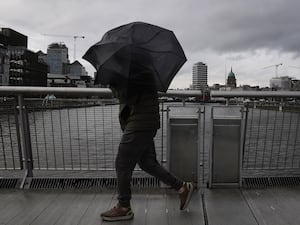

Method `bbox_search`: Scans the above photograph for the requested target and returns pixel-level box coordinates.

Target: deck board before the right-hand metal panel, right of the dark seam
[205,189,257,225]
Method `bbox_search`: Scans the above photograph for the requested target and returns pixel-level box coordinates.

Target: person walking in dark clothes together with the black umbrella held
[83,21,194,221]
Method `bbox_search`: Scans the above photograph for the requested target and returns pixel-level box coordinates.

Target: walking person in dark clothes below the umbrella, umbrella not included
[101,79,194,221]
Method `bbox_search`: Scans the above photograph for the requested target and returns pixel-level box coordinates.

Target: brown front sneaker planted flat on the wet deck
[101,204,134,221]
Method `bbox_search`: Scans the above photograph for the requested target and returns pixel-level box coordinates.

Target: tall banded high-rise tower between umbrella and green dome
[192,62,208,90]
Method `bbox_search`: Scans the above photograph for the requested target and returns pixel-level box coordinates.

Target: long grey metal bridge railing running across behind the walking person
[0,87,300,188]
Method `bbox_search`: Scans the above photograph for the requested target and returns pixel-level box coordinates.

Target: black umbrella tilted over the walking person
[83,22,186,92]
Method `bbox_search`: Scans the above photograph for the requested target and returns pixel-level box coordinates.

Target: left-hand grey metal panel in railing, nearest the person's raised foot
[167,118,199,184]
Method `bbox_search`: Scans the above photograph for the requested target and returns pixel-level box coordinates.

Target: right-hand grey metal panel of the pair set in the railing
[209,106,243,188]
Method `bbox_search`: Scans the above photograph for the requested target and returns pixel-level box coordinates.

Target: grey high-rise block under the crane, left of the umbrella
[47,43,69,74]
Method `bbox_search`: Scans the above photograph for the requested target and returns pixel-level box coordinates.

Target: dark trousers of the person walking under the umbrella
[116,130,183,207]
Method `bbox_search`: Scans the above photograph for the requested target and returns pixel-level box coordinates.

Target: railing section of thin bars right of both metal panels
[242,107,300,177]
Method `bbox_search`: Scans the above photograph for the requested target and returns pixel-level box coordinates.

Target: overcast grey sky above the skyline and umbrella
[0,0,300,88]
